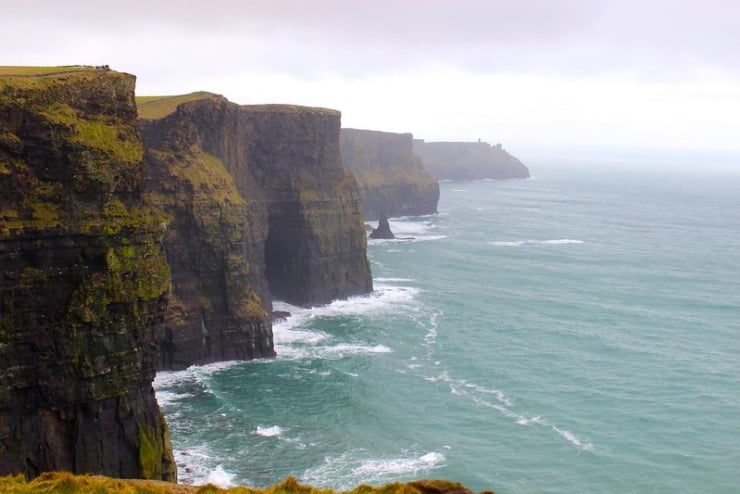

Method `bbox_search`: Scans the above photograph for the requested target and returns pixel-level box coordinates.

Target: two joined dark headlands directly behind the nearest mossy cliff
[139,93,372,368]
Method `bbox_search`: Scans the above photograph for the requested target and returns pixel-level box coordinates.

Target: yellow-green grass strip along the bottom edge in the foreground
[0,472,493,494]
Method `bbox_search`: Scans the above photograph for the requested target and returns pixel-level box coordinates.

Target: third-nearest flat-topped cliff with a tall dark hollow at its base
[240,105,372,305]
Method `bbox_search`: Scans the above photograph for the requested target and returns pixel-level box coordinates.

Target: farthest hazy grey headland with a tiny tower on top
[414,139,529,180]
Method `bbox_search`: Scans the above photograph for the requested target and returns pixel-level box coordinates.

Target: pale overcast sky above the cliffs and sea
[0,0,740,162]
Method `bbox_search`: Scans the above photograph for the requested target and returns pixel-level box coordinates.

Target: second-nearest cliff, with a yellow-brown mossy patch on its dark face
[140,95,275,369]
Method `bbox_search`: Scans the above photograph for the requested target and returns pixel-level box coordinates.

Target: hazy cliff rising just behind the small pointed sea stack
[340,129,439,220]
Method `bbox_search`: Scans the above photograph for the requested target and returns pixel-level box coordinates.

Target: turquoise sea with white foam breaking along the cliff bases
[155,167,740,494]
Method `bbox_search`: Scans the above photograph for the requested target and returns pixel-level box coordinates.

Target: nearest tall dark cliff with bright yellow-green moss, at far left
[0,70,176,480]
